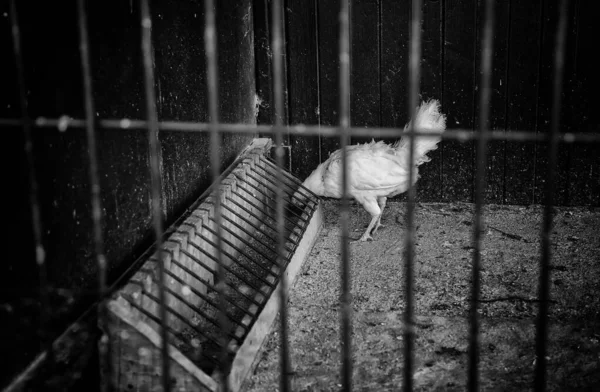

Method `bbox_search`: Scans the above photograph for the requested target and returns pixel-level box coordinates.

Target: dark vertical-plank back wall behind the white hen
[255,0,600,206]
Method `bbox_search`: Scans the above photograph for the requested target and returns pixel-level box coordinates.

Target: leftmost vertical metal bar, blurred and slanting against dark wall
[10,0,53,361]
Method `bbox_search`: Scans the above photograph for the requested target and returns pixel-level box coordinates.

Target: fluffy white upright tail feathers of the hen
[393,99,446,166]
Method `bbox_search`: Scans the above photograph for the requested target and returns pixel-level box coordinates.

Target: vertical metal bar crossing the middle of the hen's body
[339,0,352,392]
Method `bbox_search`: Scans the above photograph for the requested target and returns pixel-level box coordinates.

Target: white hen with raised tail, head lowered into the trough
[303,100,446,241]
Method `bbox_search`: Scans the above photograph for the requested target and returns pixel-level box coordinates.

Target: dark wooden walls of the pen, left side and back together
[0,0,600,384]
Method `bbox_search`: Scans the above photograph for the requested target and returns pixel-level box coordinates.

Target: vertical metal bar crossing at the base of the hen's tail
[404,0,422,391]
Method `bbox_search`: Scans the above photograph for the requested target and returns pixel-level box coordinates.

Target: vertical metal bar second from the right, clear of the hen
[468,0,494,392]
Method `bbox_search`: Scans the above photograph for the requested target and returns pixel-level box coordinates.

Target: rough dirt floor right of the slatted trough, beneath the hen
[241,201,600,392]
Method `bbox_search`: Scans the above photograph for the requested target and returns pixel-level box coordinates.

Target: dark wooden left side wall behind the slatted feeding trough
[0,0,256,390]
